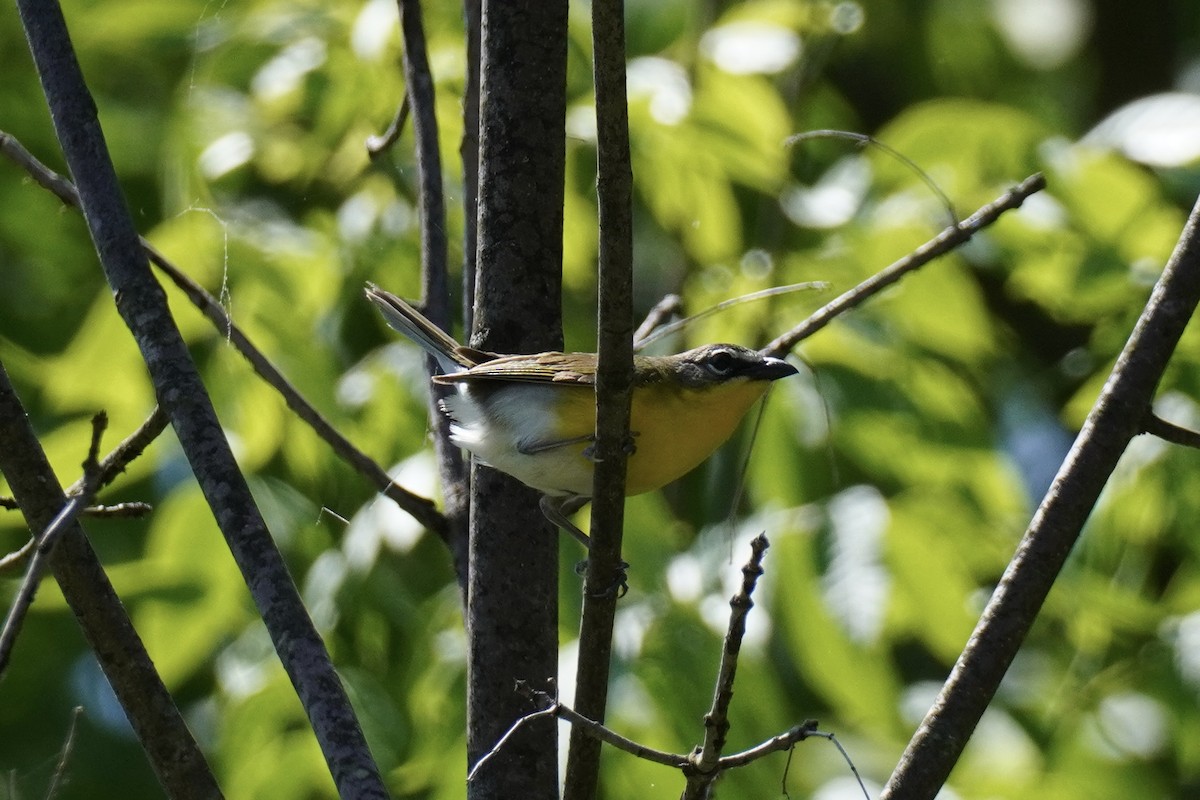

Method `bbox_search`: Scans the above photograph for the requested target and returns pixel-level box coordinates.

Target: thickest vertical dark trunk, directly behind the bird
[467,0,568,800]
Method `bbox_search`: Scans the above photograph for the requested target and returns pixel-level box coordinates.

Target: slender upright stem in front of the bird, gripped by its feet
[564,0,634,800]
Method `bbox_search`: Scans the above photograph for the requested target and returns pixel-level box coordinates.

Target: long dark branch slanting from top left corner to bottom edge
[17,0,386,798]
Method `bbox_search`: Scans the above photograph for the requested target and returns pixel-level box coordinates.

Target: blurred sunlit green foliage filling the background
[0,0,1200,800]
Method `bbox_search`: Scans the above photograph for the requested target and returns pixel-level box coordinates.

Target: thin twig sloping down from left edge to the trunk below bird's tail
[0,131,446,540]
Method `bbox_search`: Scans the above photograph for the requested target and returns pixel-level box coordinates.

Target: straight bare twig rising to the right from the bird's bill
[762,173,1046,356]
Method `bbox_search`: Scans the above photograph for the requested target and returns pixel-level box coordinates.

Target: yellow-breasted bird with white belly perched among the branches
[366,283,798,548]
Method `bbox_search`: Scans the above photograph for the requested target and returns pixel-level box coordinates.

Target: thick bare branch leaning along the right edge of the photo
[882,195,1200,800]
